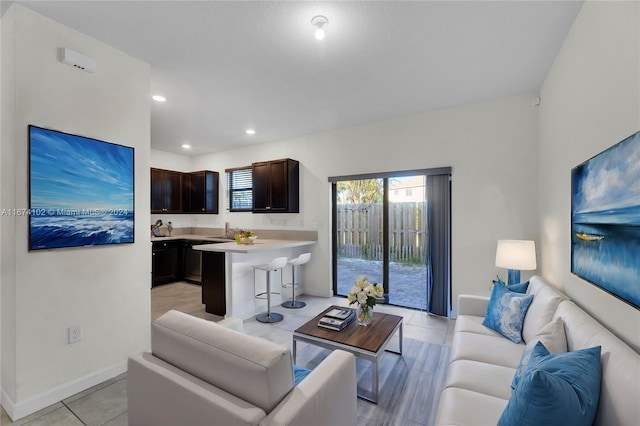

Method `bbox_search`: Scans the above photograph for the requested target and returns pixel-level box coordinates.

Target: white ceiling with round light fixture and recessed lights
[5,1,582,155]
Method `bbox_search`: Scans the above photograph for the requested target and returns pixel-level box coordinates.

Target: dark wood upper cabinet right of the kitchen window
[251,158,300,213]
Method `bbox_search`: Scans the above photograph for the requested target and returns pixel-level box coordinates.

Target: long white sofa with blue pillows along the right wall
[436,276,640,426]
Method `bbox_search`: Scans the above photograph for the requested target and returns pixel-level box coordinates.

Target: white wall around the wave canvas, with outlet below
[0,4,151,418]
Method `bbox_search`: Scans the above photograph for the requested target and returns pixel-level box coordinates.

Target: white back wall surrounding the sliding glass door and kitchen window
[160,93,538,298]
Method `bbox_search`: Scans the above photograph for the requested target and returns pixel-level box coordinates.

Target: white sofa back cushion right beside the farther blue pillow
[522,276,567,342]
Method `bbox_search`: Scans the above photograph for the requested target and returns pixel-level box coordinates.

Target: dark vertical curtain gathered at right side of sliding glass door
[426,175,451,317]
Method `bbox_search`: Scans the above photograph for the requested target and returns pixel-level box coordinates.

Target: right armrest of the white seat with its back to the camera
[260,350,358,426]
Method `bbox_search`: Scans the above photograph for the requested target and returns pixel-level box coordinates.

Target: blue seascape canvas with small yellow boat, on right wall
[571,132,640,309]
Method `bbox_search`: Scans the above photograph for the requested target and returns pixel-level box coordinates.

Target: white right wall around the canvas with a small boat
[539,1,640,350]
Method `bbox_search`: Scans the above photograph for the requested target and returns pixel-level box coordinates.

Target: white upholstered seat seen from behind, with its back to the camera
[127,311,357,426]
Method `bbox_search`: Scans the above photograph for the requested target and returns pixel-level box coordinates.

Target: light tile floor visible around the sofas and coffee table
[0,283,455,426]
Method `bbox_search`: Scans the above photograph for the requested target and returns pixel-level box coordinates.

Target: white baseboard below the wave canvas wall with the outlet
[0,362,127,421]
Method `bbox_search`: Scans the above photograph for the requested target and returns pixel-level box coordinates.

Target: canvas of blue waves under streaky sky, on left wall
[28,126,134,250]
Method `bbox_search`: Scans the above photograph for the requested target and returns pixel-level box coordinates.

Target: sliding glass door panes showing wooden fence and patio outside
[331,171,440,310]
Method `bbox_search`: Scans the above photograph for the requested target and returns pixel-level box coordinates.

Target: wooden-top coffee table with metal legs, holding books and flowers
[293,305,402,403]
